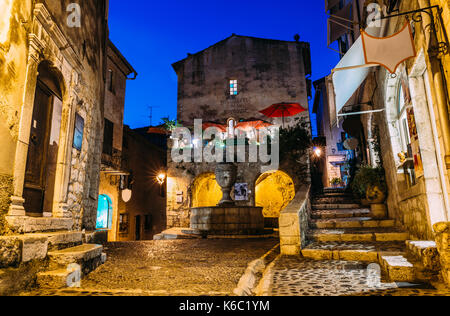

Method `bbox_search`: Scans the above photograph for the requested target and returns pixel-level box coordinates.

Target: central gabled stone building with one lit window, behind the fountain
[167,34,311,228]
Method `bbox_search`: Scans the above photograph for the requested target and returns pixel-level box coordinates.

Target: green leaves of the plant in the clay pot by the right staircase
[351,165,387,199]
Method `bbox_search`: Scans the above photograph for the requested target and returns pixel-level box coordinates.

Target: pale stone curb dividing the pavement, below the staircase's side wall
[233,244,280,296]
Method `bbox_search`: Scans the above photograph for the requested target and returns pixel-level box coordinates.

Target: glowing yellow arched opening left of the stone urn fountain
[192,173,222,207]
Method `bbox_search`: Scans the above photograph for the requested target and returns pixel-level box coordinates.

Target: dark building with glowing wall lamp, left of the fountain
[117,126,167,241]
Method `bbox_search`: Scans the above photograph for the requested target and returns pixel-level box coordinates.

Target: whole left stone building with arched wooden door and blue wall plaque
[0,0,108,293]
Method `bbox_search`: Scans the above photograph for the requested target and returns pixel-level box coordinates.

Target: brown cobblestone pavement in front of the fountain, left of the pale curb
[22,239,279,296]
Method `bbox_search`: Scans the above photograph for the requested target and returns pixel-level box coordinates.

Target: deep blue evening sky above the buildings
[109,0,339,128]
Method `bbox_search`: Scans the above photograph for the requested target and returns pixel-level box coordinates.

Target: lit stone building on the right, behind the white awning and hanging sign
[326,0,450,283]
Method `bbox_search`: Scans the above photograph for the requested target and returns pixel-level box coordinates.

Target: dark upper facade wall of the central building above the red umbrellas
[173,35,311,126]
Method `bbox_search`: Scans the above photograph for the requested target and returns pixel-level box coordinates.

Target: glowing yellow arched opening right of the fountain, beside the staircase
[255,171,295,219]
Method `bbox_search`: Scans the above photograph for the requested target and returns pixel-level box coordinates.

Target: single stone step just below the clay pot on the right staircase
[310,217,395,229]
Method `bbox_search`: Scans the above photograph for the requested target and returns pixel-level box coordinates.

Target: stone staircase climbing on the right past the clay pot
[301,189,440,283]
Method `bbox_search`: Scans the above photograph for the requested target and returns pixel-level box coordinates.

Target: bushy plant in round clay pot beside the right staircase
[351,165,387,218]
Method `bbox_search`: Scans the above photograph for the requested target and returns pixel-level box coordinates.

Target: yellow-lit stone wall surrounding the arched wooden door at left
[0,0,108,231]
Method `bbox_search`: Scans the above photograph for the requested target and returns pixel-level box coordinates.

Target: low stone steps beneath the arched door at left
[0,231,106,292]
